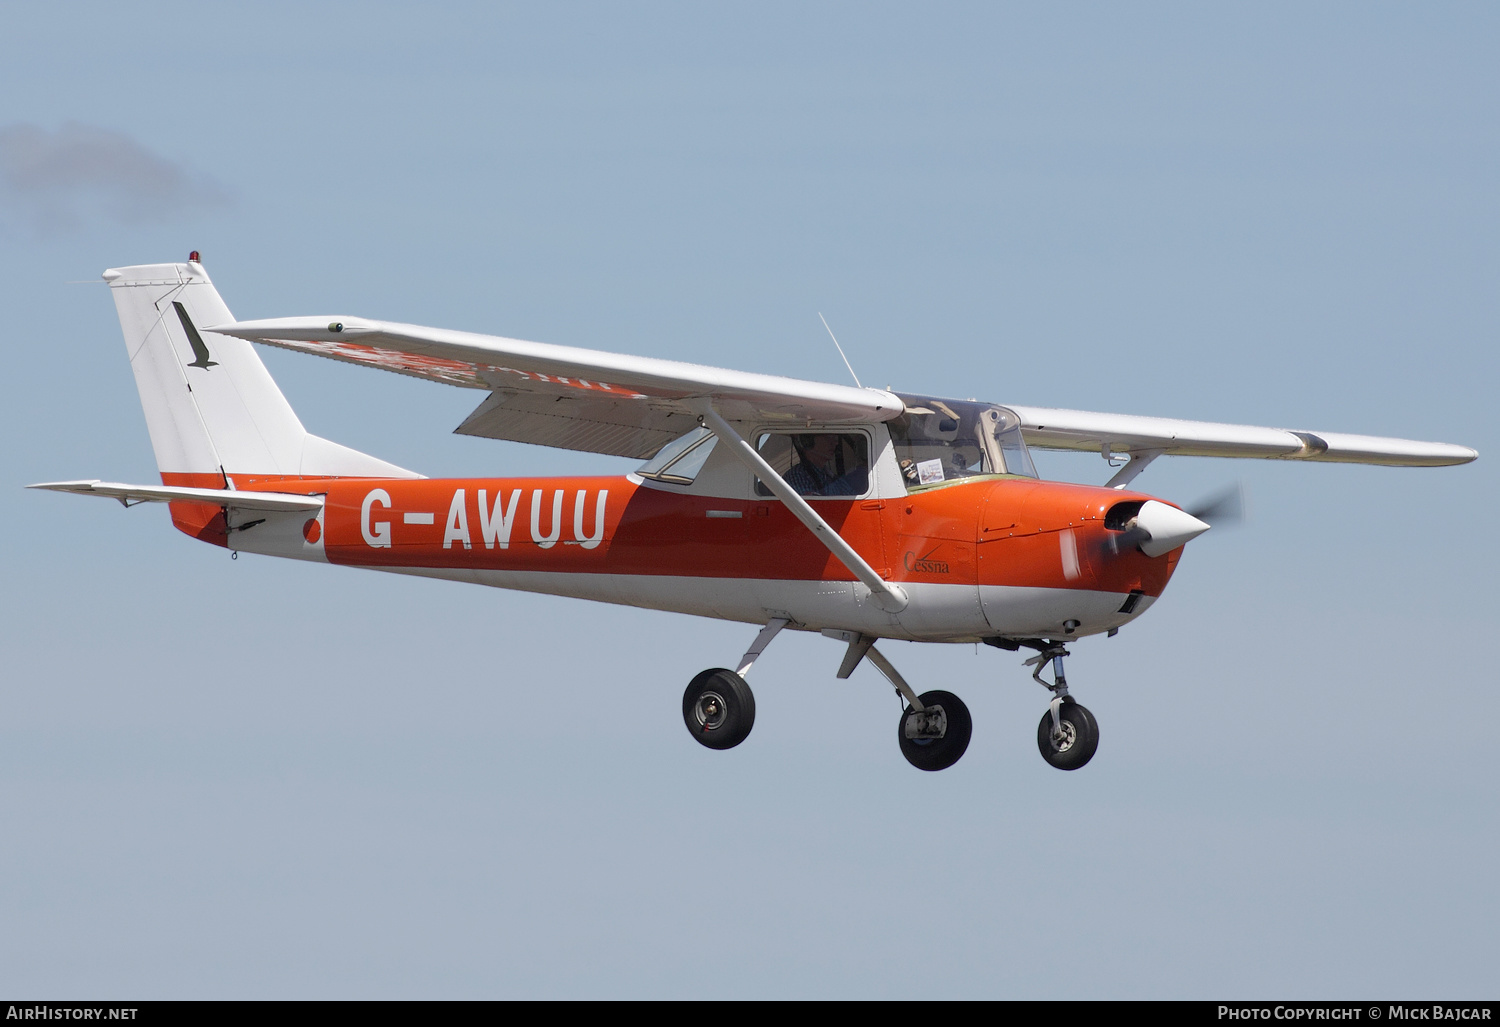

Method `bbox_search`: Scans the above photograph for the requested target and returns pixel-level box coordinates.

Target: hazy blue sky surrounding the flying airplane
[0,3,1500,999]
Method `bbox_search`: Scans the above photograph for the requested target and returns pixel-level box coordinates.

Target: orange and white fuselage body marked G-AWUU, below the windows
[162,474,1182,642]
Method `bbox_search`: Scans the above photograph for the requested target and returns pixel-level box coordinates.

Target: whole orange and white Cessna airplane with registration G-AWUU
[29,250,1479,771]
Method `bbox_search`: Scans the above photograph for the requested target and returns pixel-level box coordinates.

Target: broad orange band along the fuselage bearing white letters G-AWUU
[219,475,1182,595]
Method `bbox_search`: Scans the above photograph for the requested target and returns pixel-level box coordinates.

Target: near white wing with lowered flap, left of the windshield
[206,316,905,459]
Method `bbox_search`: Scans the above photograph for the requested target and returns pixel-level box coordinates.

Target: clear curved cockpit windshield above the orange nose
[887,393,1037,489]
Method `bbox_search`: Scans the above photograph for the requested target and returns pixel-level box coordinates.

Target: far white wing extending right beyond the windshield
[1011,406,1479,468]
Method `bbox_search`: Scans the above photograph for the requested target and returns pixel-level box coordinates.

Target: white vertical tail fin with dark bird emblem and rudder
[104,261,422,541]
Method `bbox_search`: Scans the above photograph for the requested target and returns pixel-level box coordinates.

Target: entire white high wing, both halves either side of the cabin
[206,316,1479,470]
